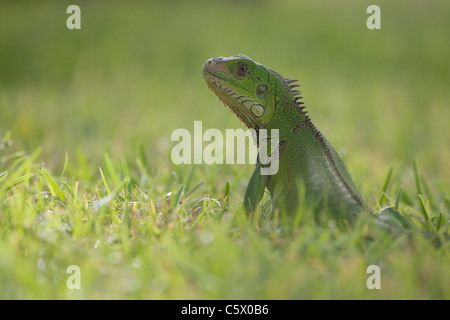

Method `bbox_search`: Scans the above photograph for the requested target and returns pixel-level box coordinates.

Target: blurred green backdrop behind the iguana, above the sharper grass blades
[0,0,450,193]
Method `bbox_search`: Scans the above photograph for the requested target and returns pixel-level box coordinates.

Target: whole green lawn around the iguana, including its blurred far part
[0,0,450,299]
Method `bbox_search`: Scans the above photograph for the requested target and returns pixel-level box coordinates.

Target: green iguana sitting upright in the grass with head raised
[203,55,364,216]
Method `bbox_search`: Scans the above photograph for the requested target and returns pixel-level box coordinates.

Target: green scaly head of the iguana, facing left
[203,55,298,130]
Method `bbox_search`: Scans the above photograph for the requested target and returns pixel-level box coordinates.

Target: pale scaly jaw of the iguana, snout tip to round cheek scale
[202,63,264,130]
